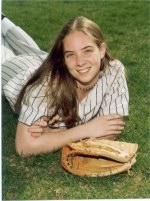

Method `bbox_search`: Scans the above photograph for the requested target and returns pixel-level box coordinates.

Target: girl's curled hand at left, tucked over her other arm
[28,116,49,137]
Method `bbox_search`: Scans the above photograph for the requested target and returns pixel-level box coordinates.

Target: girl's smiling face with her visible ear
[63,31,106,87]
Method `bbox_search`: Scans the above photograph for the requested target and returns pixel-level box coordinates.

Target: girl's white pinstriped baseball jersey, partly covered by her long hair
[4,58,129,126]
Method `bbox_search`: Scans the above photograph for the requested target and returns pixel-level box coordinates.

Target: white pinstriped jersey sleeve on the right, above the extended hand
[100,61,129,116]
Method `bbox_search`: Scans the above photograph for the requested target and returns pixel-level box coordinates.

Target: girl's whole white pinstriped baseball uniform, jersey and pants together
[2,17,129,126]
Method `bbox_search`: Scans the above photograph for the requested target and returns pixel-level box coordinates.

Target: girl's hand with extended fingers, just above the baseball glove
[88,115,125,137]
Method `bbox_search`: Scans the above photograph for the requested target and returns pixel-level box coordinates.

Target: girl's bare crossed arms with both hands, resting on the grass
[15,115,125,156]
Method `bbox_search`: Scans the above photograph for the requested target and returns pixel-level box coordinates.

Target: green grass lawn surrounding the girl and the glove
[2,0,150,200]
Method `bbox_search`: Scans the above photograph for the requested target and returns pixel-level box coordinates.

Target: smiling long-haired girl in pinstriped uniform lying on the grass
[2,17,129,156]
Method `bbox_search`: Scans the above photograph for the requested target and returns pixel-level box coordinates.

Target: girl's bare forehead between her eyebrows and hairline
[63,31,96,51]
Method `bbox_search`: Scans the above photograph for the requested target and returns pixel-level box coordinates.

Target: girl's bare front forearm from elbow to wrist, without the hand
[16,123,88,156]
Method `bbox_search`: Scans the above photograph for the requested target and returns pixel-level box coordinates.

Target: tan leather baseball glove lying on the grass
[61,139,138,177]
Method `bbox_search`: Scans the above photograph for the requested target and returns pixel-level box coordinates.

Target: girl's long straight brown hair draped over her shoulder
[15,16,113,128]
